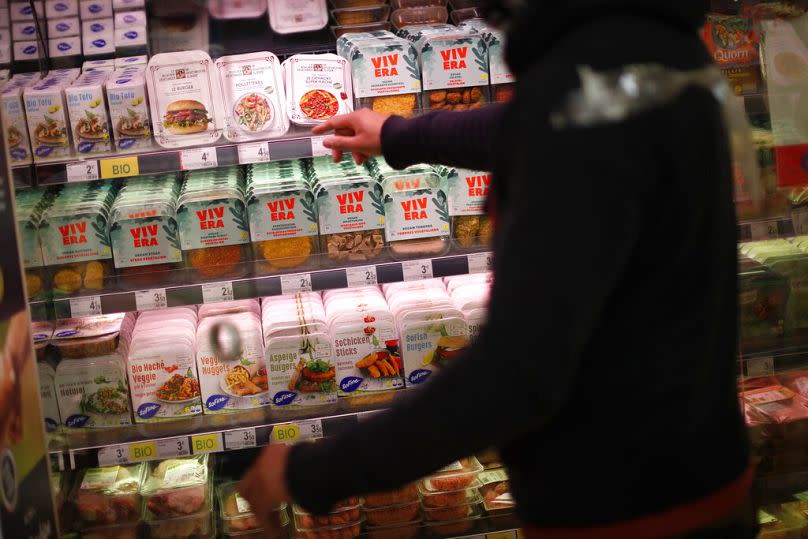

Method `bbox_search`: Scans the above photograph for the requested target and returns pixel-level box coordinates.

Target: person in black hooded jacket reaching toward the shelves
[242,0,756,539]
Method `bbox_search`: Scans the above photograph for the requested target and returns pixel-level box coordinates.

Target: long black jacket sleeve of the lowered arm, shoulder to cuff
[286,115,642,513]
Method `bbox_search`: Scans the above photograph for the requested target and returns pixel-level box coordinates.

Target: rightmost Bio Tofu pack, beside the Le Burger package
[106,71,152,150]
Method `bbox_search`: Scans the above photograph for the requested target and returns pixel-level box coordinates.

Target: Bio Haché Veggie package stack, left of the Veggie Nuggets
[127,309,202,422]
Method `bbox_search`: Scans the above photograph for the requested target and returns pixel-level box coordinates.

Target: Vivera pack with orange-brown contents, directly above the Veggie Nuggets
[177,169,250,279]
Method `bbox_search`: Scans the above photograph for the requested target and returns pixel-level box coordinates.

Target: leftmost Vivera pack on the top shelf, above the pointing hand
[346,38,421,117]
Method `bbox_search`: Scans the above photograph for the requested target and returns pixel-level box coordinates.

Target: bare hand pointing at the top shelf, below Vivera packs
[312,109,389,165]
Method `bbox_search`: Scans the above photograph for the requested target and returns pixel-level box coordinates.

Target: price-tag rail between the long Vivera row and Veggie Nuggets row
[30,251,492,320]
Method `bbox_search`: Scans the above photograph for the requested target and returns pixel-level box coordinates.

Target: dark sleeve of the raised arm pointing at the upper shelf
[382,103,506,170]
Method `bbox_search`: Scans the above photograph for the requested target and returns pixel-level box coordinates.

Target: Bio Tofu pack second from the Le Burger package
[65,75,112,155]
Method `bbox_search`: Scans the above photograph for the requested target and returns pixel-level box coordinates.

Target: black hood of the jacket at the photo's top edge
[487,0,710,76]
